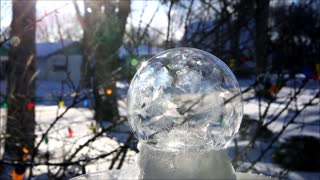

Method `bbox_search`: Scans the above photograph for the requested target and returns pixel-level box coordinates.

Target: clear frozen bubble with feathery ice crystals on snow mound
[127,48,243,151]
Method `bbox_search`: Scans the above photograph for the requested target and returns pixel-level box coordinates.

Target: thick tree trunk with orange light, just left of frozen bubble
[94,0,130,121]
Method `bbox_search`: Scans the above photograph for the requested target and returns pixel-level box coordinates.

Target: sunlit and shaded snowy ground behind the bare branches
[0,80,320,179]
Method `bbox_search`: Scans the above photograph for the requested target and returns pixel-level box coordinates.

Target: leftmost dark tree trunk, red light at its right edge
[5,0,36,160]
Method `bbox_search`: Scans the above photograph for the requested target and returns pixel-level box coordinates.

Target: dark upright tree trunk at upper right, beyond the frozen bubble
[255,0,270,74]
